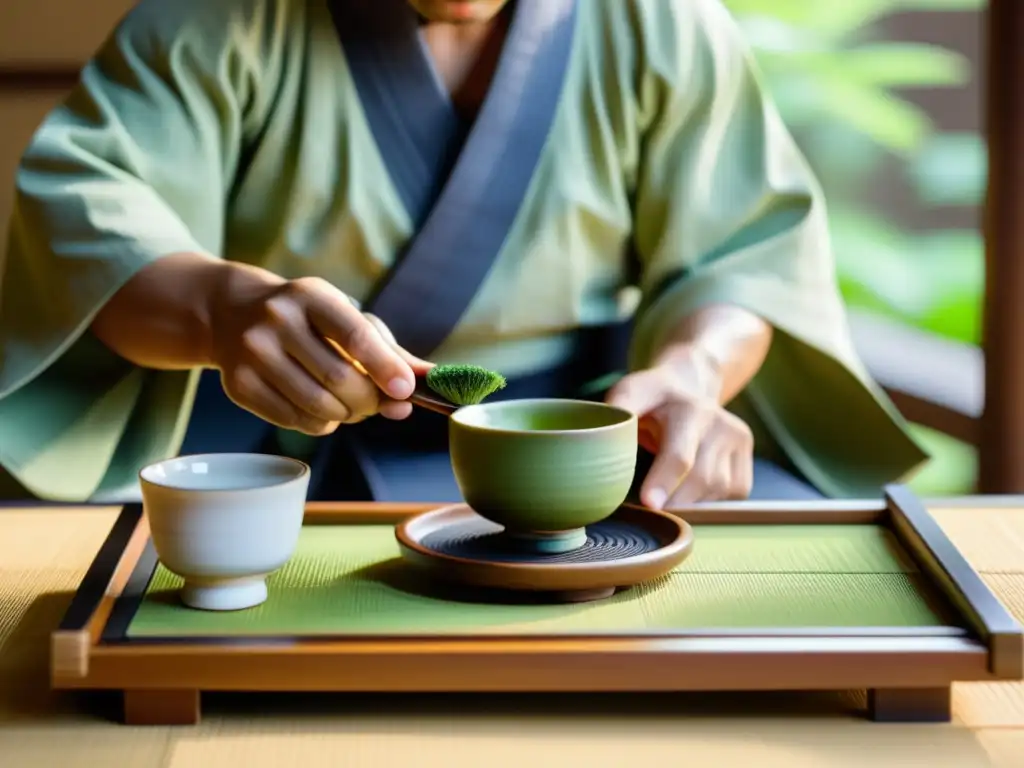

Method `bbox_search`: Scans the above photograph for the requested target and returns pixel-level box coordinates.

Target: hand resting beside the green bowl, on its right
[607,356,754,509]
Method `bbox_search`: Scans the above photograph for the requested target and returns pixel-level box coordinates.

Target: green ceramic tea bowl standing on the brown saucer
[449,399,637,552]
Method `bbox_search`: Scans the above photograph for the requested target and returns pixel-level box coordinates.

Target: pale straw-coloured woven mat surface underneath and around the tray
[0,509,1024,768]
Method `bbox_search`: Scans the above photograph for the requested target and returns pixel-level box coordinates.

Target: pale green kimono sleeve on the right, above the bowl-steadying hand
[631,0,927,497]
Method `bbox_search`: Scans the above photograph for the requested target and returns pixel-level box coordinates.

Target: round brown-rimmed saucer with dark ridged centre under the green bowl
[395,504,693,602]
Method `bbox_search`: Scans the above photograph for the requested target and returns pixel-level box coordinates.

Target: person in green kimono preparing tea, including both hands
[0,0,926,508]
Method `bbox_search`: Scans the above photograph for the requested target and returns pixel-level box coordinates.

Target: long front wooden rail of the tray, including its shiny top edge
[59,638,997,692]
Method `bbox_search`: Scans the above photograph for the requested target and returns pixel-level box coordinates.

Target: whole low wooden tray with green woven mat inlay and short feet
[50,486,1024,724]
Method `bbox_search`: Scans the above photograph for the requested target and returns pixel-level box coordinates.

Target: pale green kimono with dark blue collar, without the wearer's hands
[0,0,926,501]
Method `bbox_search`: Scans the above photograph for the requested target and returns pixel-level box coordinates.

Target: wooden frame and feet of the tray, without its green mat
[50,485,1024,724]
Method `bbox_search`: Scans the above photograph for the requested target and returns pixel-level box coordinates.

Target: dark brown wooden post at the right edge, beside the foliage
[978,0,1024,494]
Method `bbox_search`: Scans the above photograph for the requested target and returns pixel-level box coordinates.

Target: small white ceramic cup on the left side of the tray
[139,454,309,610]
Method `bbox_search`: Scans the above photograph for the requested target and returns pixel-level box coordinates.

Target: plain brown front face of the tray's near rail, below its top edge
[51,653,997,693]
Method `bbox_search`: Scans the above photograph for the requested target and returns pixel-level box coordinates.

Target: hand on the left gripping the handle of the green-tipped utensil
[210,268,430,435]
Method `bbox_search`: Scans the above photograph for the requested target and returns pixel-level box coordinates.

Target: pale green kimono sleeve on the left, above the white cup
[0,0,284,501]
